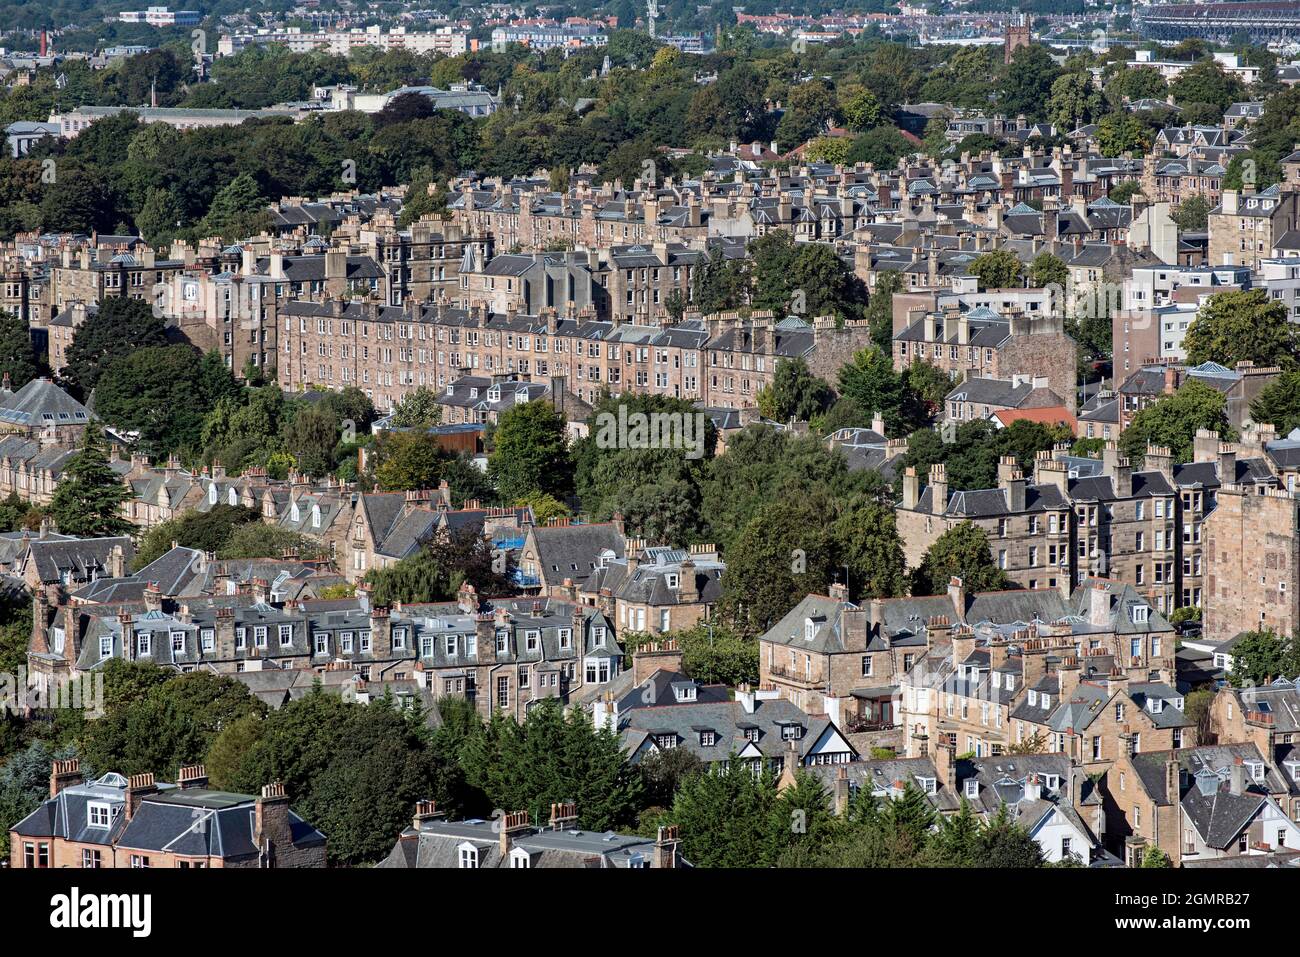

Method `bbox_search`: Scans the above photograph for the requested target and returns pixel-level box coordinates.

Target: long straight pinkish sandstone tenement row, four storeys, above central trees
[277,299,871,408]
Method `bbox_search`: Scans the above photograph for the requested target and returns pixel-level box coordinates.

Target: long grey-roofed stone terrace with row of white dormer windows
[27,579,623,720]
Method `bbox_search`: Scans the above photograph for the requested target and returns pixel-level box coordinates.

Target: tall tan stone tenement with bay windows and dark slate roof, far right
[896,432,1274,616]
